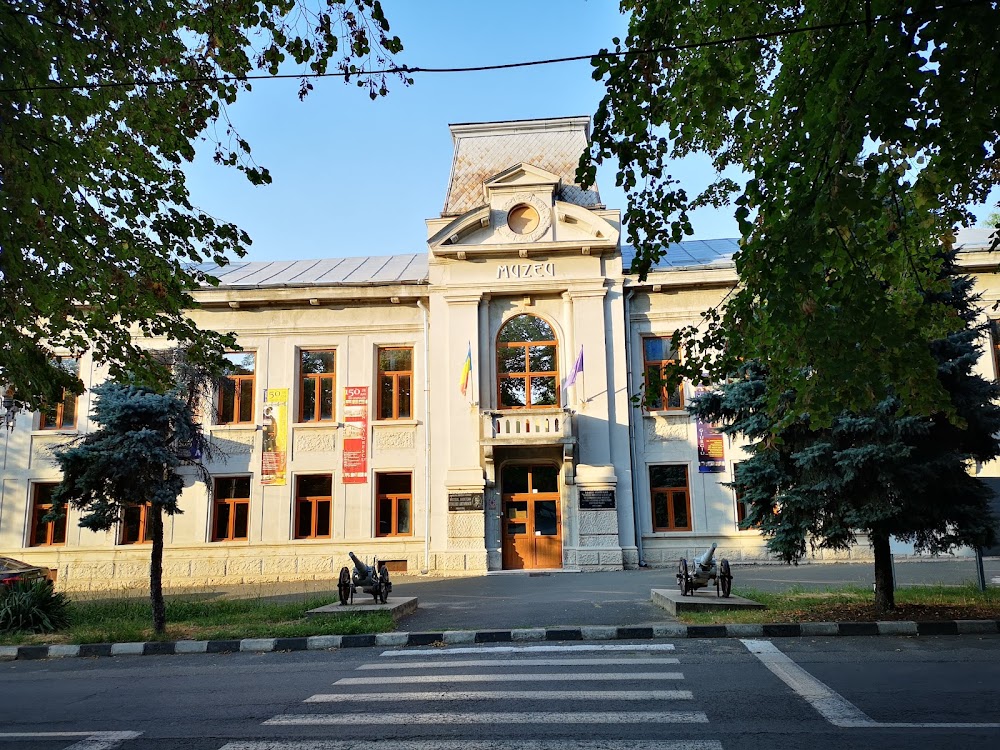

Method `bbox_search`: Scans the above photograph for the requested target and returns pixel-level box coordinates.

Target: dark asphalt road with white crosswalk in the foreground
[0,636,1000,750]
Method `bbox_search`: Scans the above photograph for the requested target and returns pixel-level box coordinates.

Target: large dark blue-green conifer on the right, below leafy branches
[690,254,1000,612]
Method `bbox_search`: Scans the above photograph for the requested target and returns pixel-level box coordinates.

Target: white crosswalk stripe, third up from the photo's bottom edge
[305,690,693,703]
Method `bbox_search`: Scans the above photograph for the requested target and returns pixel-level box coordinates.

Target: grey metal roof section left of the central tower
[197,253,427,289]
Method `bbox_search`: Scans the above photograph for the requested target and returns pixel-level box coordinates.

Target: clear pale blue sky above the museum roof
[187,0,987,260]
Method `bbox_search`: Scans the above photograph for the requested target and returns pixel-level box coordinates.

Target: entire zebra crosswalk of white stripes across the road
[249,644,723,750]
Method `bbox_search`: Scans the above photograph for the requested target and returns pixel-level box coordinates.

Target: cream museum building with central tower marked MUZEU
[0,117,998,589]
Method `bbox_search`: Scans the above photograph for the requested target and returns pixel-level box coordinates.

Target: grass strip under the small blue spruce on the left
[0,596,394,645]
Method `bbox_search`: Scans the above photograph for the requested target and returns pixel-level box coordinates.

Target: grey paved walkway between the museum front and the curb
[172,558,1000,632]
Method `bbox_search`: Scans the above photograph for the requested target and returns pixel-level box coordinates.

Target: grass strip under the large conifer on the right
[678,585,1000,625]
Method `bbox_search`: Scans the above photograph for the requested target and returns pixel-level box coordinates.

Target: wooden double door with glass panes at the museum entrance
[500,464,562,570]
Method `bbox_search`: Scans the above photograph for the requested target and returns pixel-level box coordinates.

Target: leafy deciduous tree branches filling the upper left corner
[0,0,409,406]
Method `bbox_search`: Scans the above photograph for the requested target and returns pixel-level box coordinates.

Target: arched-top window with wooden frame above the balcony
[497,314,559,409]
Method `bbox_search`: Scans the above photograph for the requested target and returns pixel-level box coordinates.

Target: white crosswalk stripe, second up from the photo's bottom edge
[264,711,708,726]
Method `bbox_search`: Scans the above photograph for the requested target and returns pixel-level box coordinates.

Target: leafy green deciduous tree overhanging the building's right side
[581,0,1000,430]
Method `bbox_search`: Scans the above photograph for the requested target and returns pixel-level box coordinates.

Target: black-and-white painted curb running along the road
[0,620,1000,661]
